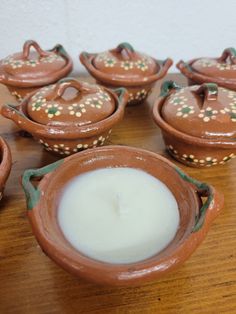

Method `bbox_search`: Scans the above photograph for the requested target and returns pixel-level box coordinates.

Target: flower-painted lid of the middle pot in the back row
[93,43,160,80]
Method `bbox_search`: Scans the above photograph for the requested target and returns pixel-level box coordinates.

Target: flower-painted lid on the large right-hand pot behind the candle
[161,81,236,139]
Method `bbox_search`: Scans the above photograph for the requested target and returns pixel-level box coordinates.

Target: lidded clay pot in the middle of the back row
[80,43,173,105]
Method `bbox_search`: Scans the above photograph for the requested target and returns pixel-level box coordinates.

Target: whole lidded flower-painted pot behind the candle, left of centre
[2,78,128,156]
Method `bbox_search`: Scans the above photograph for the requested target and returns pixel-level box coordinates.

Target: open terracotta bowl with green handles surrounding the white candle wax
[22,146,223,285]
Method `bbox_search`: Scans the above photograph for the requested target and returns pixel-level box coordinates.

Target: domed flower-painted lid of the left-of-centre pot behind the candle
[27,78,116,126]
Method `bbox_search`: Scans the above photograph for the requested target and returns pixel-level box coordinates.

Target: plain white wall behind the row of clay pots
[0,0,236,72]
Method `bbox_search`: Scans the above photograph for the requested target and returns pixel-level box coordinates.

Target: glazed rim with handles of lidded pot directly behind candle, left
[1,87,128,140]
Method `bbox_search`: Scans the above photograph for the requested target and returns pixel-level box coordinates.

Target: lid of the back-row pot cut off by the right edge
[191,48,236,79]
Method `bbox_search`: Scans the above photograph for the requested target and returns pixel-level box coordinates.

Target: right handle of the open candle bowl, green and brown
[176,168,224,233]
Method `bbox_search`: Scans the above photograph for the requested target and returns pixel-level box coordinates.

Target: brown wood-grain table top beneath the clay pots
[0,75,236,314]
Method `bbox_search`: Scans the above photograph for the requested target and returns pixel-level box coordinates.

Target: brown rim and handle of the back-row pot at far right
[176,58,236,88]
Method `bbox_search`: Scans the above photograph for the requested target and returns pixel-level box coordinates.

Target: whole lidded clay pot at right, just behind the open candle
[153,81,236,167]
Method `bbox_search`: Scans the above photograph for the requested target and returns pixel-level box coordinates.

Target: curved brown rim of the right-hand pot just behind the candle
[153,96,236,148]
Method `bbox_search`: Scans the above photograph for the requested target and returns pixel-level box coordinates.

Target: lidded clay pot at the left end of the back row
[0,40,72,101]
